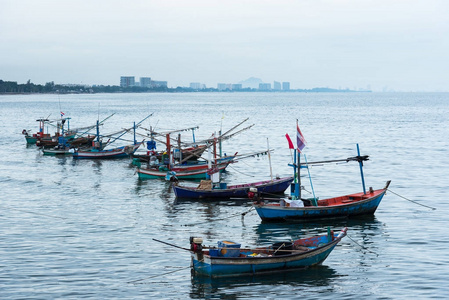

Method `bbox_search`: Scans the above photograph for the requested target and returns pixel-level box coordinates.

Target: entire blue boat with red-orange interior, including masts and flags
[253,120,391,221]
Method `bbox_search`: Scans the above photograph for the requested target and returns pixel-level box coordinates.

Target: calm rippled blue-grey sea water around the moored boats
[0,93,449,299]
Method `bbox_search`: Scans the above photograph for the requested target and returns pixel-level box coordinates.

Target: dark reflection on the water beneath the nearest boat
[190,265,343,299]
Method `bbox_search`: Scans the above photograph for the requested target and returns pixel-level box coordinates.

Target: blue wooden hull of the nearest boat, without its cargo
[191,230,346,277]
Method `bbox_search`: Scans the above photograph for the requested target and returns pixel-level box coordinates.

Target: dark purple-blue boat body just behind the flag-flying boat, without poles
[173,177,293,199]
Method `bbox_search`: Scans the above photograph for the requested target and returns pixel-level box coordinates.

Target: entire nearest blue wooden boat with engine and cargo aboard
[186,228,347,277]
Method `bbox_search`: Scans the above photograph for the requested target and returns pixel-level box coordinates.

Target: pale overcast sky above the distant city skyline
[0,0,449,91]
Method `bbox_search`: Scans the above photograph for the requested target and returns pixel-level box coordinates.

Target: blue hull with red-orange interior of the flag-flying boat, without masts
[254,181,390,221]
